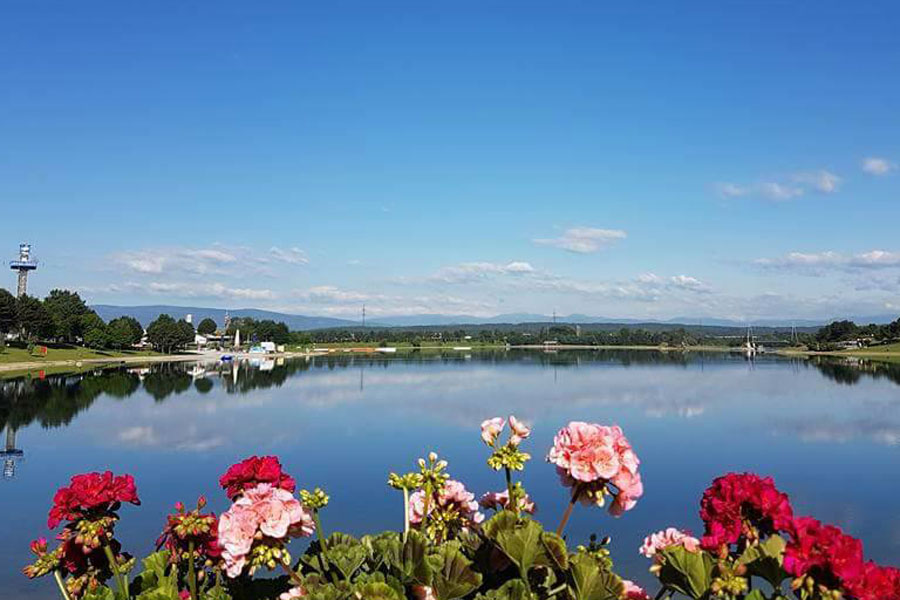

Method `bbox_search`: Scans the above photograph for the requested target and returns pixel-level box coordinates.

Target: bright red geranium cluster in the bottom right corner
[784,517,900,600]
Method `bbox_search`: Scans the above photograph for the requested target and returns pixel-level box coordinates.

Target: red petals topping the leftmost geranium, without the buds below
[47,471,141,529]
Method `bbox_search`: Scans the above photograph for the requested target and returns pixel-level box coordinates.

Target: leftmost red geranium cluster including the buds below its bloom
[23,471,140,598]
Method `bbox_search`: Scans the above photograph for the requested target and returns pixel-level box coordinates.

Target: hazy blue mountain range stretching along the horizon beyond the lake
[91,304,897,331]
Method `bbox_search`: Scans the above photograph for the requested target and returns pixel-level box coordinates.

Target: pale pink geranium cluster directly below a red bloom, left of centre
[218,476,315,577]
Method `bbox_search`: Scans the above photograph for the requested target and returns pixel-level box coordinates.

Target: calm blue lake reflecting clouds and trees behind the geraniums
[0,351,900,599]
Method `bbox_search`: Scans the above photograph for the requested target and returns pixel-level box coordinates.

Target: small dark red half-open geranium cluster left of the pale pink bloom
[156,496,222,566]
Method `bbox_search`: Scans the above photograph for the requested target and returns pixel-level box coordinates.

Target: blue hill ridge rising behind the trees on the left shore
[91,304,359,331]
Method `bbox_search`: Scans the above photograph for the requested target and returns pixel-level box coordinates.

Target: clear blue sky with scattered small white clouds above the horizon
[0,0,900,320]
